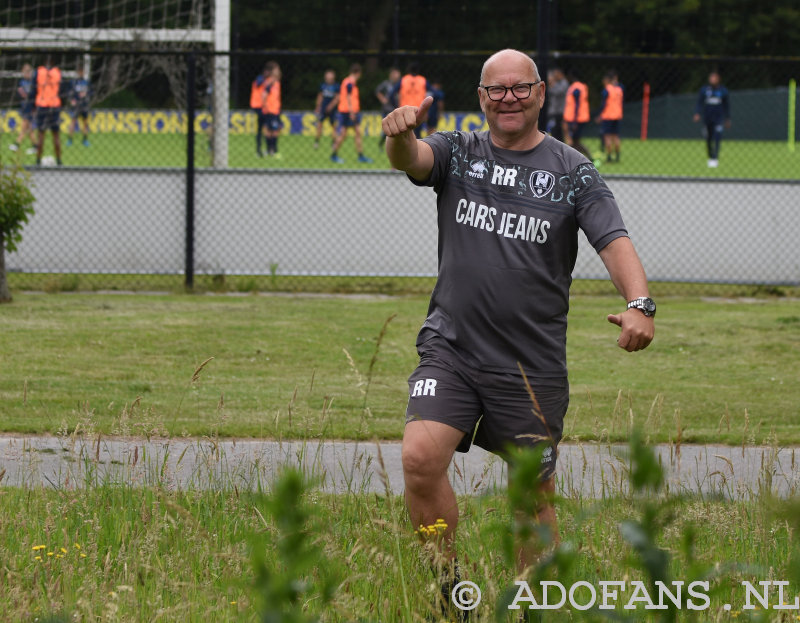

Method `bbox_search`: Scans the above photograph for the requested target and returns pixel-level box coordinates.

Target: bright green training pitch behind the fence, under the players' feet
[7,134,800,180]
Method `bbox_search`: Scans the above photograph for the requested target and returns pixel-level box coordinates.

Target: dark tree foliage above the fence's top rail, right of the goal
[233,0,800,56]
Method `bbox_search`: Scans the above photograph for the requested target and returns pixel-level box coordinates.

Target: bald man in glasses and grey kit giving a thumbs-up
[383,50,655,618]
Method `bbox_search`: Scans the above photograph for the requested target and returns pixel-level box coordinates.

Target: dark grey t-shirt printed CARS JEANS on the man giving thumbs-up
[412,132,627,378]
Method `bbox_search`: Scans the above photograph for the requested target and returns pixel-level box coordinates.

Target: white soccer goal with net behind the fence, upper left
[0,0,230,167]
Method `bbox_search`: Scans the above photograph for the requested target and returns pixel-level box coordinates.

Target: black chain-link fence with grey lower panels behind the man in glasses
[0,49,800,292]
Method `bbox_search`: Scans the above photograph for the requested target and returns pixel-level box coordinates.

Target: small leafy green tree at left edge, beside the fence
[0,163,35,303]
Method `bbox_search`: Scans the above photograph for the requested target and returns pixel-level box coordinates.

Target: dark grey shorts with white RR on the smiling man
[406,338,569,478]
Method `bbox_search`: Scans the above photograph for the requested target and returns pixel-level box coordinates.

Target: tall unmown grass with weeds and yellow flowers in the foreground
[0,442,800,623]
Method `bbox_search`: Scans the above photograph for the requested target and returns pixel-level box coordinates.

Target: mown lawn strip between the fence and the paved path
[0,294,800,444]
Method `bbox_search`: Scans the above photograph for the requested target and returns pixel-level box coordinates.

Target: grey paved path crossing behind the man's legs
[0,436,800,499]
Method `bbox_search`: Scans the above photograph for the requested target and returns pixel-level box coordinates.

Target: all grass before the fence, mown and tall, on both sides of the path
[0,294,800,623]
